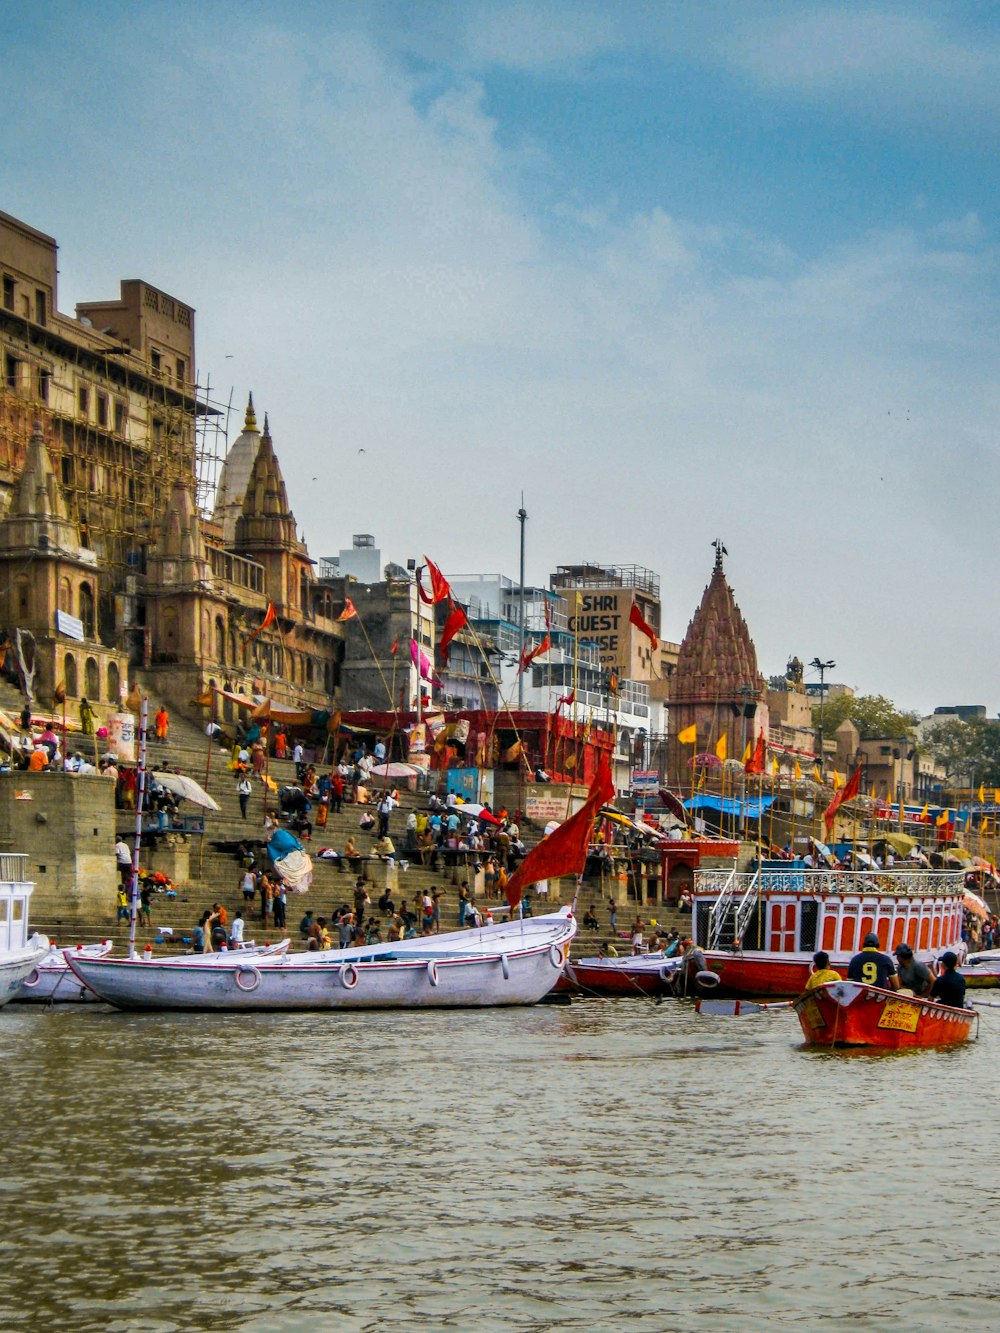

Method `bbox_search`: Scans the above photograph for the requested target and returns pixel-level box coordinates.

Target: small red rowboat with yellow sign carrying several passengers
[793,981,979,1050]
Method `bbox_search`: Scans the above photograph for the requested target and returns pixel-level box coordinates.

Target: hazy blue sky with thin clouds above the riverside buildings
[0,0,1000,712]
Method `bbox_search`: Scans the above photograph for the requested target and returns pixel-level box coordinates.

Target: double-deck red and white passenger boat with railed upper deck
[692,862,965,996]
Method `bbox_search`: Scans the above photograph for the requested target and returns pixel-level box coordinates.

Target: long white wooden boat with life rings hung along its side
[68,908,576,1009]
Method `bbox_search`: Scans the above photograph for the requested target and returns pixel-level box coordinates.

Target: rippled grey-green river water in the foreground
[0,1000,1000,1333]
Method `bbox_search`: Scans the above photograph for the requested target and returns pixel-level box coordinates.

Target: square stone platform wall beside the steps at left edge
[0,772,117,924]
